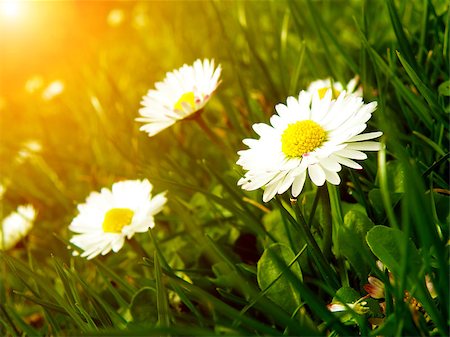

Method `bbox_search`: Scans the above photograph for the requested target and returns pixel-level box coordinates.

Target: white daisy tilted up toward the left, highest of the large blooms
[136,59,221,137]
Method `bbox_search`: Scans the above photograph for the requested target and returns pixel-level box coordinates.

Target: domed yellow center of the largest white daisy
[281,120,326,157]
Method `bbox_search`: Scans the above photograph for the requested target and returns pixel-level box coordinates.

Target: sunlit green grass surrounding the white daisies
[0,0,450,336]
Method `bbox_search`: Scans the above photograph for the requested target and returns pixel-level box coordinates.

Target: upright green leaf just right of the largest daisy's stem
[338,211,374,280]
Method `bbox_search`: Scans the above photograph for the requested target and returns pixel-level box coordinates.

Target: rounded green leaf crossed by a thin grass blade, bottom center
[257,243,302,313]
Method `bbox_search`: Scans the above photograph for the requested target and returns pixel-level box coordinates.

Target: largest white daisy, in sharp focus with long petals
[237,90,382,202]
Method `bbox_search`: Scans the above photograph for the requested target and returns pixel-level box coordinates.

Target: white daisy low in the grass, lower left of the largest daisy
[69,179,167,259]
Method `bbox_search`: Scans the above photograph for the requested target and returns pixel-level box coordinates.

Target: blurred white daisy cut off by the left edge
[0,205,36,250]
